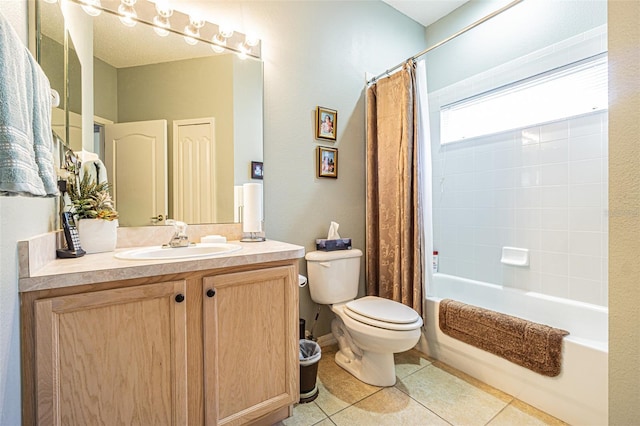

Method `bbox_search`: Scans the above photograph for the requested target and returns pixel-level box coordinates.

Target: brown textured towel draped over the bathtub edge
[439,299,569,377]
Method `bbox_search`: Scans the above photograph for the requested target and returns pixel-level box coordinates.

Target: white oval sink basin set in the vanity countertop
[114,243,242,260]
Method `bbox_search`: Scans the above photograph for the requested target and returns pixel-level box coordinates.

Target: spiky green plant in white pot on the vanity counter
[67,173,118,253]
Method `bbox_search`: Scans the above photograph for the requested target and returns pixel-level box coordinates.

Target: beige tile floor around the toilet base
[278,346,565,426]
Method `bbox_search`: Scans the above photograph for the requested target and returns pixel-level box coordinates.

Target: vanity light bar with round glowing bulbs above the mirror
[70,0,262,59]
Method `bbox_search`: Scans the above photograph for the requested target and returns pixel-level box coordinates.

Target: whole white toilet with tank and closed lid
[305,249,422,386]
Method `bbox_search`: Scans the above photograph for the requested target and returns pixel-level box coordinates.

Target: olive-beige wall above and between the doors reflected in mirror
[117,55,235,222]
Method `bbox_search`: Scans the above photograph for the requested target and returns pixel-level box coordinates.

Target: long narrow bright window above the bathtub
[440,53,608,144]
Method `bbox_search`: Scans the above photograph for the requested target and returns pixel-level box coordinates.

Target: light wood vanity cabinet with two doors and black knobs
[21,260,299,425]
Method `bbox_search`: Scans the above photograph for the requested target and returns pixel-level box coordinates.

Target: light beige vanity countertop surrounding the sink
[19,240,304,292]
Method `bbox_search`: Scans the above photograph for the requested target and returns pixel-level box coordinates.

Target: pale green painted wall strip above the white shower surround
[425,0,607,92]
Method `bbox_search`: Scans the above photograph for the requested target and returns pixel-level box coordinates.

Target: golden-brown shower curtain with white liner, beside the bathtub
[366,60,432,315]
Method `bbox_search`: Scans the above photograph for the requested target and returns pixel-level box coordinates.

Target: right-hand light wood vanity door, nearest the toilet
[203,265,299,425]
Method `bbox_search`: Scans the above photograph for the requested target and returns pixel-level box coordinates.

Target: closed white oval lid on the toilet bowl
[344,296,422,330]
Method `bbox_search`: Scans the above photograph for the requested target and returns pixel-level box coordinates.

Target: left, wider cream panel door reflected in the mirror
[104,120,168,226]
